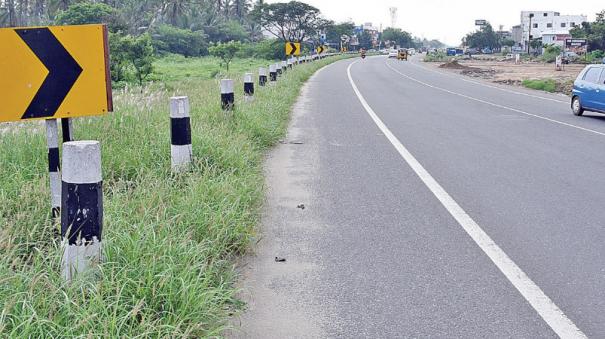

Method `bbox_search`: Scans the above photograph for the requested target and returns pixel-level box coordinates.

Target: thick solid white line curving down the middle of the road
[347,61,586,338]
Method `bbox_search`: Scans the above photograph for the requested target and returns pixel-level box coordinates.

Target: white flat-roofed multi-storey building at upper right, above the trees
[521,11,588,47]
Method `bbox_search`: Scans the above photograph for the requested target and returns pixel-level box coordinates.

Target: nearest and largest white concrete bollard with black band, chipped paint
[61,141,103,282]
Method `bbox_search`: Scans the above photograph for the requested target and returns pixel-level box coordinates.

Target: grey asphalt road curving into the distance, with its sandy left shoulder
[231,57,605,338]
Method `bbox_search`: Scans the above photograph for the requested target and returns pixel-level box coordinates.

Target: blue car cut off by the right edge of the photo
[571,65,605,115]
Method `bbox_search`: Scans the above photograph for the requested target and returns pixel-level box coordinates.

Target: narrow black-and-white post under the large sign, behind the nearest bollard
[46,119,61,219]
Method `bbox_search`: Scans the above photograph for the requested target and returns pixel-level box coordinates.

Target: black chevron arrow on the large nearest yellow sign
[15,28,82,119]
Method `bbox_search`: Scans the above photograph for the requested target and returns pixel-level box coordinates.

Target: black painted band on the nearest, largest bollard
[61,181,103,245]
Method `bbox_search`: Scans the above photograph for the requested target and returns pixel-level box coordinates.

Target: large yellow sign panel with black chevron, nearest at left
[0,25,113,122]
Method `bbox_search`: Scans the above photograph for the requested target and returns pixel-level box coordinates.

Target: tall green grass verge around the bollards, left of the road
[0,58,350,338]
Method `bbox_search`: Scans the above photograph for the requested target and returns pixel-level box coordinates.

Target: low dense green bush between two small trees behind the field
[153,25,208,57]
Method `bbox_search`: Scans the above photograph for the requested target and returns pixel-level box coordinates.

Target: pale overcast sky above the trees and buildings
[266,0,605,45]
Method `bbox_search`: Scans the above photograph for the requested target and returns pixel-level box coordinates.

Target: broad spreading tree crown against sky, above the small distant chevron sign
[252,1,330,42]
